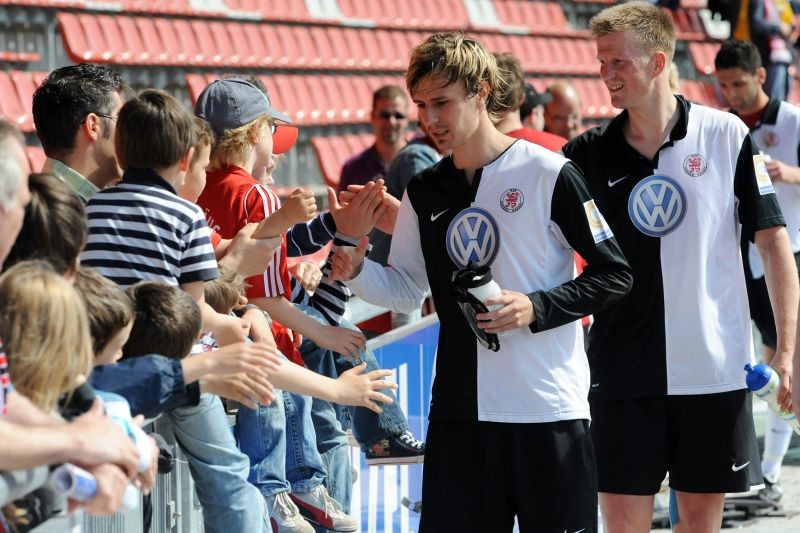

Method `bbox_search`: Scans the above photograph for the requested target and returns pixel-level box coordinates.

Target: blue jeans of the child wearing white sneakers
[236,386,326,496]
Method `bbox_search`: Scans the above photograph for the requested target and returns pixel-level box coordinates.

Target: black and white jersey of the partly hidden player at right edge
[736,98,800,278]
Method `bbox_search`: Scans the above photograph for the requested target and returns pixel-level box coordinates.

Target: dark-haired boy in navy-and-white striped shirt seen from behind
[81,90,217,290]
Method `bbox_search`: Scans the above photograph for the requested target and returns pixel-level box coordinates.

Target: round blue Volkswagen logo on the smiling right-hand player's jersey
[628,174,687,237]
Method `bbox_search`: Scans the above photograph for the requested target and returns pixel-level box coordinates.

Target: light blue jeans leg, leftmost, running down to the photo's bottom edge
[167,394,271,533]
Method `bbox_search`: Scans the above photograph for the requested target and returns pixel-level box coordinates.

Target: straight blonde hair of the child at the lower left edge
[0,261,94,411]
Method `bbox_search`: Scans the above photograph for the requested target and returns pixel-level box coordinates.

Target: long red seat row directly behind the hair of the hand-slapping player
[58,13,597,74]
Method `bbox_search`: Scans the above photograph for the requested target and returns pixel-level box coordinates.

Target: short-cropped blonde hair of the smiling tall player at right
[589,1,675,61]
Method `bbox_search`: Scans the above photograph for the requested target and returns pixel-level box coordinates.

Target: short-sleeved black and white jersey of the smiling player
[564,97,783,398]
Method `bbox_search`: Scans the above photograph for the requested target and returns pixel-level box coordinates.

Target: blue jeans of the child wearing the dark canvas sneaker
[295,304,408,444]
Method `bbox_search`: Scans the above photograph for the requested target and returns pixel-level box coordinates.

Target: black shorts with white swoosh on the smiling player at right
[589,389,763,495]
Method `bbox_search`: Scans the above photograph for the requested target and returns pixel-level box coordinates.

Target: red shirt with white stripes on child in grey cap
[197,167,304,365]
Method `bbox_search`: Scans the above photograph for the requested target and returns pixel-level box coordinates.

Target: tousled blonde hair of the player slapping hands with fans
[406,32,509,118]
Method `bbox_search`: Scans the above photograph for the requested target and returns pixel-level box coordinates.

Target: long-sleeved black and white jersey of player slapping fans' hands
[348,141,631,423]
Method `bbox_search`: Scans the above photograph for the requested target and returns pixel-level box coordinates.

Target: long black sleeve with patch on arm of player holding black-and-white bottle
[528,163,633,333]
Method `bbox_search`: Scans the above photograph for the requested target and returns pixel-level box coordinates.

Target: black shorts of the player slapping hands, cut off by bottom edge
[419,420,597,533]
